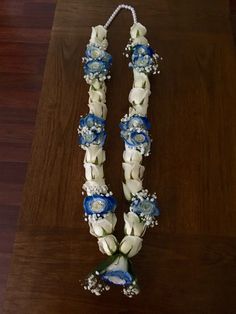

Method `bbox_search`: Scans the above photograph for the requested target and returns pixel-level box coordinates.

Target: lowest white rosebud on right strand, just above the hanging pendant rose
[119,235,143,257]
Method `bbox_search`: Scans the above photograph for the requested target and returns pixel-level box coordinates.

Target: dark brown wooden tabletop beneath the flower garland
[2,0,236,314]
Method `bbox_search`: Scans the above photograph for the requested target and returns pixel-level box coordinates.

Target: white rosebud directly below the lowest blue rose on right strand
[124,212,146,237]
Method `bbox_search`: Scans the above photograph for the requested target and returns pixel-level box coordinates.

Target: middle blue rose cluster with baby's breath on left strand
[78,113,106,149]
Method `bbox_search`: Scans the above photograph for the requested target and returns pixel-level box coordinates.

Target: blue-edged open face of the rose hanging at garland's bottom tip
[101,270,133,286]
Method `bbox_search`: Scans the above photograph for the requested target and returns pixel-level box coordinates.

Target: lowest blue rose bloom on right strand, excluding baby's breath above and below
[130,198,160,216]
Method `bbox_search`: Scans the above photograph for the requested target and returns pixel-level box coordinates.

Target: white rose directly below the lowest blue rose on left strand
[89,213,117,237]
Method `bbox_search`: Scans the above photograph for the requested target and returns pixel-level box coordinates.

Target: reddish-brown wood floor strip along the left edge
[0,0,55,313]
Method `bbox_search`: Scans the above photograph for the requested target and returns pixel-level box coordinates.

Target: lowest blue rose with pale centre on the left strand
[83,194,117,215]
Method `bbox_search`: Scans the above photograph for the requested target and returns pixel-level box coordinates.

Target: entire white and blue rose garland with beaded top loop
[78,4,160,297]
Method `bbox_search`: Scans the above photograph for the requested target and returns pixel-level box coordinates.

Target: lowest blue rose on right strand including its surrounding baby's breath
[130,190,160,226]
